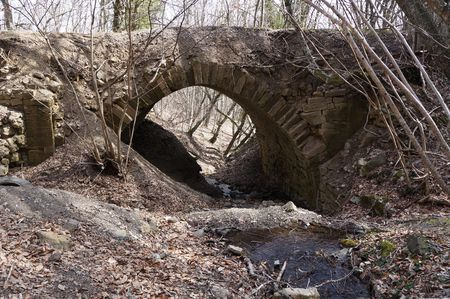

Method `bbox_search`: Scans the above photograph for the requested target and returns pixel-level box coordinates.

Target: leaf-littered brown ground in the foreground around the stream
[0,116,450,298]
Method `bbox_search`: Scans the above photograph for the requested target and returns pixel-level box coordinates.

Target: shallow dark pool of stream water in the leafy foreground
[229,229,370,299]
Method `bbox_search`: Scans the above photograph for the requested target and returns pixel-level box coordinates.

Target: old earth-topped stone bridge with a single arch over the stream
[0,27,400,210]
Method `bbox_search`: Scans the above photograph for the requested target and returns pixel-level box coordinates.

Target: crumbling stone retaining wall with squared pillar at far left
[0,65,64,171]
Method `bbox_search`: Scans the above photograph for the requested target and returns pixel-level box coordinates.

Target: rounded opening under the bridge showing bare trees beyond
[128,86,286,199]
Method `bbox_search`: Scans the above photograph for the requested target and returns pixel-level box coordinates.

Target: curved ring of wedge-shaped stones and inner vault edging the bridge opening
[106,60,366,209]
